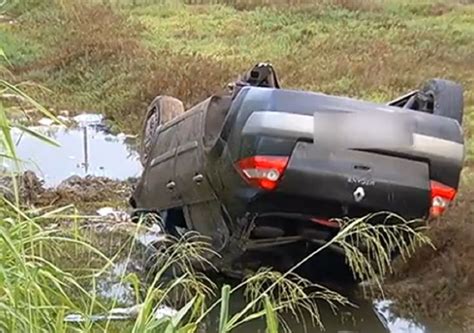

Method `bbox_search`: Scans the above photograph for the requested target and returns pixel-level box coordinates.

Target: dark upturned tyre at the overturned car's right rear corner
[420,79,464,125]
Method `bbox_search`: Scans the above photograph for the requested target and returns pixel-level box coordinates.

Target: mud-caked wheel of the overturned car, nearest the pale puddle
[140,96,184,166]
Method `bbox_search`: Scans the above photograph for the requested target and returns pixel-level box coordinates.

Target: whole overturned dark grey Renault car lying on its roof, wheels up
[130,64,464,274]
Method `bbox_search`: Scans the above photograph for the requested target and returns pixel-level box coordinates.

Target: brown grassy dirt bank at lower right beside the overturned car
[385,172,474,331]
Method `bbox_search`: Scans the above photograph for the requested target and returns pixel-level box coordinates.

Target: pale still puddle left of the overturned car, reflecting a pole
[9,114,141,186]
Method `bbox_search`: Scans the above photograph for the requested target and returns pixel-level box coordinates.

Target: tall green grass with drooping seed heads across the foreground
[0,72,427,333]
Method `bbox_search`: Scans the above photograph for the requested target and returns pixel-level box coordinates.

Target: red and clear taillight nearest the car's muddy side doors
[237,156,288,190]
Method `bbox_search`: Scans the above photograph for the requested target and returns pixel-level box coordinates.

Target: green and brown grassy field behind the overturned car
[0,0,474,163]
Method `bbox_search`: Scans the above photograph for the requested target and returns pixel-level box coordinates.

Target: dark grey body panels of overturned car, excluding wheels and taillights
[132,87,464,264]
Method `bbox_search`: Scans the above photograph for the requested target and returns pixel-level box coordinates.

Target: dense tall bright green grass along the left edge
[0,52,94,332]
